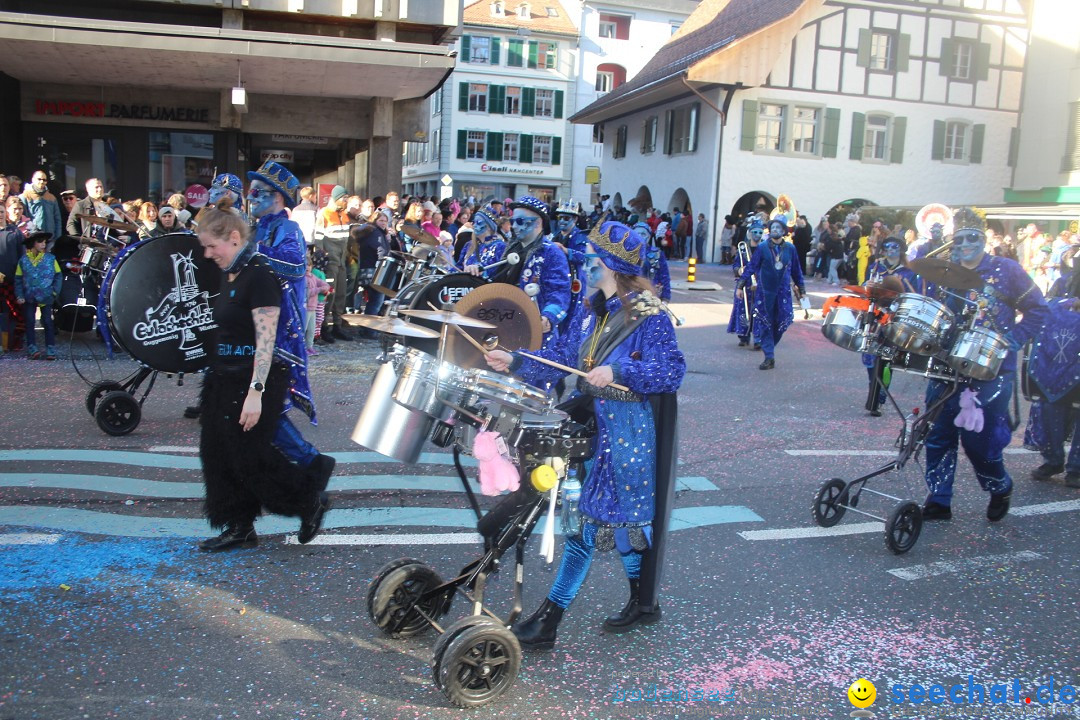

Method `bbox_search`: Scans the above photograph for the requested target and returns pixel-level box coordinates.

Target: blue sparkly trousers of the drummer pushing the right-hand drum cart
[926,372,1013,506]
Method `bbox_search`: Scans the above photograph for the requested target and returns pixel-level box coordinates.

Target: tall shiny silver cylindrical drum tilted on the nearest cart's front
[352,363,435,463]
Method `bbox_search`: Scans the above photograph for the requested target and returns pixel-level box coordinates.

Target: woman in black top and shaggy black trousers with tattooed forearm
[199,208,329,552]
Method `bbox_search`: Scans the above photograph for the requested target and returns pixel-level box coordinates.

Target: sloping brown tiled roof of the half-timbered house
[570,0,806,122]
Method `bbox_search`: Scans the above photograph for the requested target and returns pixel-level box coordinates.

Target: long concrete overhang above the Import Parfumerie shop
[0,13,455,101]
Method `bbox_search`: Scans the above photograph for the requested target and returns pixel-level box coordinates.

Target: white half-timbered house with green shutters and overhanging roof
[571,0,1028,257]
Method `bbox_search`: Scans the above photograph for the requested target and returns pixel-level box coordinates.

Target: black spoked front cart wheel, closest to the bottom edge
[433,623,522,708]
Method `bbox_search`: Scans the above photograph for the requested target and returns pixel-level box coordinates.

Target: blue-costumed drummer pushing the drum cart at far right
[922,208,1049,521]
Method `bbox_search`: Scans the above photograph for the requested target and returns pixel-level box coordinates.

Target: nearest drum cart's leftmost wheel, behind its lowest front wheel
[369,562,449,638]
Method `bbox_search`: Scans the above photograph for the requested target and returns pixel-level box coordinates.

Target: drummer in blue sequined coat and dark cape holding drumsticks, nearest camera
[487,222,686,649]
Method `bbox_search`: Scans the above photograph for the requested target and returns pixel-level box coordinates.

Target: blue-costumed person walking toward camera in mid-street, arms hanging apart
[735,215,806,370]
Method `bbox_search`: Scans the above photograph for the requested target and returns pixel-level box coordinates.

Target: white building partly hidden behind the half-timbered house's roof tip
[568,0,698,204]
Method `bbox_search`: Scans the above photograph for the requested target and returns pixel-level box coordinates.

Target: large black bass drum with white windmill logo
[103,232,221,372]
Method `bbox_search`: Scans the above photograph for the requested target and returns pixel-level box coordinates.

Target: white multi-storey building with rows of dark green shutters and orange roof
[402,0,578,202]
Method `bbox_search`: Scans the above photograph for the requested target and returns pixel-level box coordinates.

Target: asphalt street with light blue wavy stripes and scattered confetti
[0,263,1080,720]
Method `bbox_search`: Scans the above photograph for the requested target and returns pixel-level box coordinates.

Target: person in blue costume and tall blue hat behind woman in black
[247,160,335,481]
